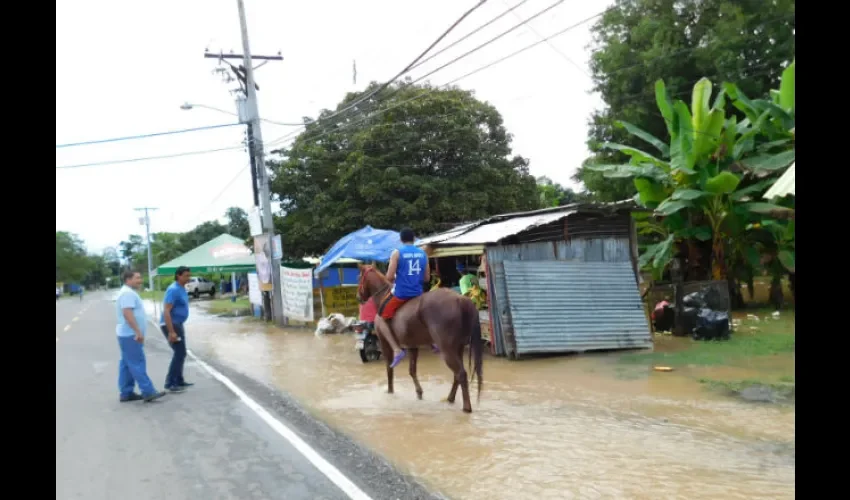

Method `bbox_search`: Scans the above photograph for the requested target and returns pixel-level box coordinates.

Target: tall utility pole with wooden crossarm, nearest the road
[236,0,284,325]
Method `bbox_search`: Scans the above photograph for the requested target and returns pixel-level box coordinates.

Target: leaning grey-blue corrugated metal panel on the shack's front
[503,260,652,357]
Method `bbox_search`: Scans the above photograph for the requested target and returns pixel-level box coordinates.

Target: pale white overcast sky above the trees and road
[56,0,612,251]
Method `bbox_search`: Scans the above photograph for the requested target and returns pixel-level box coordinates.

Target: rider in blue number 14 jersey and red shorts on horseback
[378,229,436,368]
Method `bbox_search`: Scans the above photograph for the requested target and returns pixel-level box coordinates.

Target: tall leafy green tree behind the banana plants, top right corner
[574,0,795,201]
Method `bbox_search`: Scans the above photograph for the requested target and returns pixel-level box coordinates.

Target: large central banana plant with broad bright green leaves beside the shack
[591,66,794,279]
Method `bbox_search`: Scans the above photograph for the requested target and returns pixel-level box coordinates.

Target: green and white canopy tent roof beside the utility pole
[156,234,256,276]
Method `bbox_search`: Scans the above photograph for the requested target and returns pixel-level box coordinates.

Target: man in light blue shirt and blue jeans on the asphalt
[115,271,165,403]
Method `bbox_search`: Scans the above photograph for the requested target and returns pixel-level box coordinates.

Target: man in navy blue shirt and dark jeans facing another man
[159,266,192,392]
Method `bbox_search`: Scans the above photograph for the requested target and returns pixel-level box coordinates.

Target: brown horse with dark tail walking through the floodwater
[357,266,483,413]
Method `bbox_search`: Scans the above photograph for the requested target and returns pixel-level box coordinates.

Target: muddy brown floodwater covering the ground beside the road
[182,311,795,500]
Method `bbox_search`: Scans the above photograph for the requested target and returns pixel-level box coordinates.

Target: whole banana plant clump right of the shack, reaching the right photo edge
[591,63,796,304]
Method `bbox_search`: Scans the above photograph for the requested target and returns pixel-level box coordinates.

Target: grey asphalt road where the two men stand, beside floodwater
[56,293,435,500]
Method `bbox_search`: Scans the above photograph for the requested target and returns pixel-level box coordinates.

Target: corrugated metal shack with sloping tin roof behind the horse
[421,201,652,359]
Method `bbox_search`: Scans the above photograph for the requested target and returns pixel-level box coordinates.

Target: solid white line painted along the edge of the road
[146,320,372,500]
